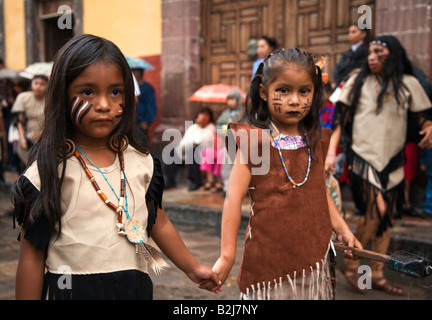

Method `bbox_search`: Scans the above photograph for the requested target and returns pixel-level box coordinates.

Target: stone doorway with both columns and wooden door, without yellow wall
[154,0,432,154]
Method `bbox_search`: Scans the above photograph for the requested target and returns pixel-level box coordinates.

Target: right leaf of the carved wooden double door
[285,0,375,85]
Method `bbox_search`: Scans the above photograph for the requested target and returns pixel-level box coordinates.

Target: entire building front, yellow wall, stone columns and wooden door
[0,0,432,154]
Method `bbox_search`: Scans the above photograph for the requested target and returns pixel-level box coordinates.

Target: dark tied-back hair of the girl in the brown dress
[246,48,324,158]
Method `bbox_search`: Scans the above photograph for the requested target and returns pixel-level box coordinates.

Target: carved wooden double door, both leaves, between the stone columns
[201,0,375,90]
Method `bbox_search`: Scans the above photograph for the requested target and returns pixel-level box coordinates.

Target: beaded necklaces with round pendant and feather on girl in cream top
[74,147,169,274]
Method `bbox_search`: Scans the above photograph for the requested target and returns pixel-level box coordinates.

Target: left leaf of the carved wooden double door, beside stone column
[201,0,285,90]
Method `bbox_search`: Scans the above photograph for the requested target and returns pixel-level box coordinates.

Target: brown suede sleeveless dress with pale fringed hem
[228,123,332,299]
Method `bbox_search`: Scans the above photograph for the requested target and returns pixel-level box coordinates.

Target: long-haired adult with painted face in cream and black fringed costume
[326,36,432,295]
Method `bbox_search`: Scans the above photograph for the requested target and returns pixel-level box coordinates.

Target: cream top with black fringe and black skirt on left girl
[13,146,164,299]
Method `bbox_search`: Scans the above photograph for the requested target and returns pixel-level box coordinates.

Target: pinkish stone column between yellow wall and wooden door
[152,0,201,156]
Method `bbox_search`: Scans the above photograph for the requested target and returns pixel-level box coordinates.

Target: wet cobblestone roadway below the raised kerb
[0,210,432,300]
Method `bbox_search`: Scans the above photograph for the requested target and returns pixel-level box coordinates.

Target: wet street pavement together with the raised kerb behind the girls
[0,171,432,301]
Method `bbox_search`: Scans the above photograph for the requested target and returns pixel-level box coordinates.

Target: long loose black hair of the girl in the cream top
[19,34,148,233]
